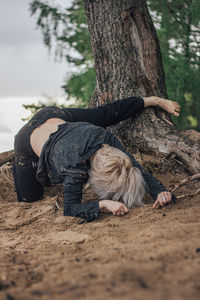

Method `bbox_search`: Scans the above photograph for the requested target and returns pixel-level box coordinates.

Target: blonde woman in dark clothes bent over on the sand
[13,96,180,221]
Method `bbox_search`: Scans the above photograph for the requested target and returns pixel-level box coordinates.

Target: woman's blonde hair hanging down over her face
[89,145,145,208]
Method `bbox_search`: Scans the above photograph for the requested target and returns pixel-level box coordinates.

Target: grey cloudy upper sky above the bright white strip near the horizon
[0,0,71,97]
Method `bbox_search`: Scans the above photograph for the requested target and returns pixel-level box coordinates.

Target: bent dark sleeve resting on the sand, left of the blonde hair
[63,169,99,222]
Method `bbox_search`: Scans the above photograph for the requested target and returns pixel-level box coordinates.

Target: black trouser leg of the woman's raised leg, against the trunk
[63,97,144,128]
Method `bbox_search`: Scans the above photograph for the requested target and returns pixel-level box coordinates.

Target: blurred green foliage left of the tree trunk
[30,0,96,107]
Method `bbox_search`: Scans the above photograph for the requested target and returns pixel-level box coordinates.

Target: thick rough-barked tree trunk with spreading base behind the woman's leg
[84,0,200,173]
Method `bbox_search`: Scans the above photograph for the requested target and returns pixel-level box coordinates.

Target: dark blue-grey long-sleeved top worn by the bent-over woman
[37,122,166,221]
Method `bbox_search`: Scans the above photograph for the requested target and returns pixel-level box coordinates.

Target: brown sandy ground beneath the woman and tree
[0,158,200,300]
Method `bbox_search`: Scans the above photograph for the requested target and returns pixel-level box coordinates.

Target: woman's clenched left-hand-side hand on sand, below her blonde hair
[99,200,129,216]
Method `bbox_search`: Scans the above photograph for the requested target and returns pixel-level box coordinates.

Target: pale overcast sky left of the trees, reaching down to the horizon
[0,0,72,152]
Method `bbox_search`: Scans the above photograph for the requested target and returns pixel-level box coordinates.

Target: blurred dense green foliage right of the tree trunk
[148,0,200,130]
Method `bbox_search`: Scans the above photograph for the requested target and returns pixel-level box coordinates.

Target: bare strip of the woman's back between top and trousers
[30,118,66,157]
